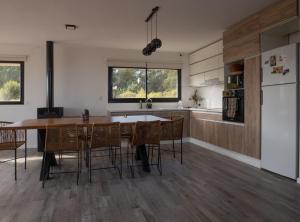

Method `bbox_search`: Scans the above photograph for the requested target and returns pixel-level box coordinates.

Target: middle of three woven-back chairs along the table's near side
[89,123,122,182]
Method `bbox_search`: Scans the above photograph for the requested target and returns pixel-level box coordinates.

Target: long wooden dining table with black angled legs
[4,115,170,179]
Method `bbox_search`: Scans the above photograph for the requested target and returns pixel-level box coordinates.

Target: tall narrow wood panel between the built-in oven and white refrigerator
[244,56,261,159]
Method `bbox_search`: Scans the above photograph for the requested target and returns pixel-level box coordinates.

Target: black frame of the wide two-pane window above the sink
[108,66,181,103]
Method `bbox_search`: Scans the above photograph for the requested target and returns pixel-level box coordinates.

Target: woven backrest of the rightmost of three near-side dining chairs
[132,121,161,145]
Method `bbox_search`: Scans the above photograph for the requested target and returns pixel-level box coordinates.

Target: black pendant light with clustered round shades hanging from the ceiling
[143,6,162,56]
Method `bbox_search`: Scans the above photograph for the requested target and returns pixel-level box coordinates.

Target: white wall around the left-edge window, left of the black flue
[0,44,46,146]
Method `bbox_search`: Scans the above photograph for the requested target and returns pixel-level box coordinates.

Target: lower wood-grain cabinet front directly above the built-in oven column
[223,33,260,63]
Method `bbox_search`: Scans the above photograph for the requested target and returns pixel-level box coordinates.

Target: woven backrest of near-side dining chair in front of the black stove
[45,125,79,152]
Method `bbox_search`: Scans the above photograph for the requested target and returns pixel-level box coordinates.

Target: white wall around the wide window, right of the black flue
[54,43,189,115]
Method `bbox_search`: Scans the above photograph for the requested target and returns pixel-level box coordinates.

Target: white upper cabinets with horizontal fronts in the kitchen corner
[189,40,224,87]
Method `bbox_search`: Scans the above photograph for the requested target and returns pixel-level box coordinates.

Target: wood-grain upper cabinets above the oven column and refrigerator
[223,0,298,63]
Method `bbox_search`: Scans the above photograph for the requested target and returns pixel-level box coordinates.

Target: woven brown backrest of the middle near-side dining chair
[90,122,121,148]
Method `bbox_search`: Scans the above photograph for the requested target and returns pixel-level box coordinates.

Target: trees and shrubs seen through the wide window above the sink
[112,68,178,98]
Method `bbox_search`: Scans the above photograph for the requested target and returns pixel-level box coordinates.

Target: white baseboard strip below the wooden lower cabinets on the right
[189,138,261,168]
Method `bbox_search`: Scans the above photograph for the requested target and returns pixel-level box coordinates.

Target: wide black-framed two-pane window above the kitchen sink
[108,67,181,103]
